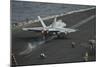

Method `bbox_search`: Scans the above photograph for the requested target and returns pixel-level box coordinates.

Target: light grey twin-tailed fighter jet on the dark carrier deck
[22,16,77,37]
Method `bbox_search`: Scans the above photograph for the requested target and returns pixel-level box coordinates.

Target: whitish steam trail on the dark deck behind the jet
[19,36,57,55]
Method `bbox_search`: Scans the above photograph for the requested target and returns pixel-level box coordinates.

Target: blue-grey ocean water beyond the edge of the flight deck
[11,1,94,23]
